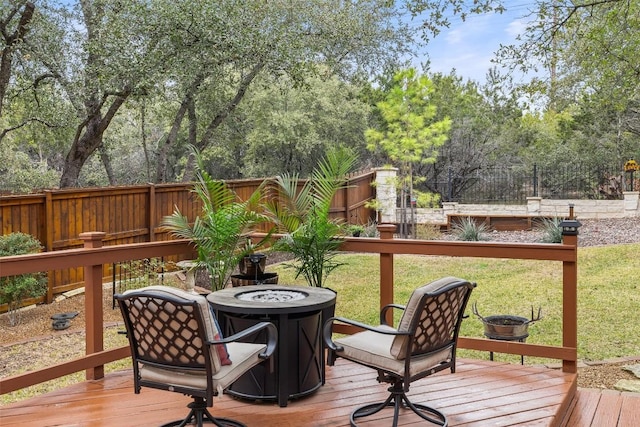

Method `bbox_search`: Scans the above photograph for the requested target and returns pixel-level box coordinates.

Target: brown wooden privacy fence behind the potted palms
[0,171,375,304]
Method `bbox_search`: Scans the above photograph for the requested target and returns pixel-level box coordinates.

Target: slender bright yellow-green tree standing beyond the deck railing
[365,68,451,236]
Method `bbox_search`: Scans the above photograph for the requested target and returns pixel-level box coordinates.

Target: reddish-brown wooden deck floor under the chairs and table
[0,359,640,427]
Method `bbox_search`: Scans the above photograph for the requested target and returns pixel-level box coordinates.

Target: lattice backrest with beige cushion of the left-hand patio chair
[115,286,221,374]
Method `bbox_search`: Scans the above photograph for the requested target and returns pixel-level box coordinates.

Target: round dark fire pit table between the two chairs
[207,285,336,407]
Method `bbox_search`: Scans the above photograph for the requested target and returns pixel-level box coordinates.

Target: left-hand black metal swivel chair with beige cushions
[115,286,277,427]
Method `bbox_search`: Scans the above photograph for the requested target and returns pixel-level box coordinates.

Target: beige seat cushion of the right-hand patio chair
[335,325,451,376]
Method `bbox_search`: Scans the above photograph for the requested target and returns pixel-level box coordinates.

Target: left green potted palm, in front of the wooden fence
[162,148,270,291]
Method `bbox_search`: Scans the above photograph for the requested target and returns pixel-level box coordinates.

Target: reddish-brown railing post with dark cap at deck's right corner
[560,205,582,373]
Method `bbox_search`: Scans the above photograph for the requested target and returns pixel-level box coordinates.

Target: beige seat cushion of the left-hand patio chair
[140,342,266,394]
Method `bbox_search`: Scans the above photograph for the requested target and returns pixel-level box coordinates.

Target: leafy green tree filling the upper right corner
[499,0,640,171]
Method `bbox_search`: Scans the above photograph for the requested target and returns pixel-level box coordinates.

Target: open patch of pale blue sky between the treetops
[414,0,532,82]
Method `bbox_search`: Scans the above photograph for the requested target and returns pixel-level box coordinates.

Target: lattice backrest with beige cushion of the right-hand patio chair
[391,277,475,359]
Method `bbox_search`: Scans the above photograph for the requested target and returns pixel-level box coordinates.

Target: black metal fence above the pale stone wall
[428,165,628,204]
